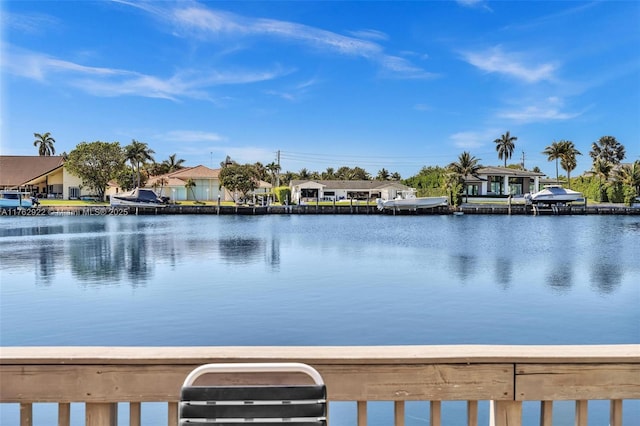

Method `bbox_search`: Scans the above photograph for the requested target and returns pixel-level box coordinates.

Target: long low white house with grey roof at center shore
[289,179,409,204]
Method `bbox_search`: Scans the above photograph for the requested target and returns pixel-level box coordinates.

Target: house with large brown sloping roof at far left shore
[0,155,91,200]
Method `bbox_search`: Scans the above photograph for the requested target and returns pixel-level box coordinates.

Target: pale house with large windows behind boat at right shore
[465,166,544,196]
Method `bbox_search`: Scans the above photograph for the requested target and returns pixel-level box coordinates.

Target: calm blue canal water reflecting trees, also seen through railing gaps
[0,215,640,426]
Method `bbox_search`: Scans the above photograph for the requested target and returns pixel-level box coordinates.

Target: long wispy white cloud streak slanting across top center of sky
[118,0,434,78]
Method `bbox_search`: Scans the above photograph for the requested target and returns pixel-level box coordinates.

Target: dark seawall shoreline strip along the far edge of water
[6,204,640,217]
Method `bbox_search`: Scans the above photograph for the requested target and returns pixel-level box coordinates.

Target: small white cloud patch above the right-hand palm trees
[462,46,558,83]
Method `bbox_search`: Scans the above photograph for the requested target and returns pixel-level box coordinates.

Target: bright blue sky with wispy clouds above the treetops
[0,0,640,178]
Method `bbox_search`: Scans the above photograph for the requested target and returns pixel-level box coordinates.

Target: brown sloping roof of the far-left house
[0,155,64,188]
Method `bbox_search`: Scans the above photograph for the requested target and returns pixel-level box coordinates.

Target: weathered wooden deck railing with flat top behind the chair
[0,345,640,426]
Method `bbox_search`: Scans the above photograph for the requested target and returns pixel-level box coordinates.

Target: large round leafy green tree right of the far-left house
[64,141,126,200]
